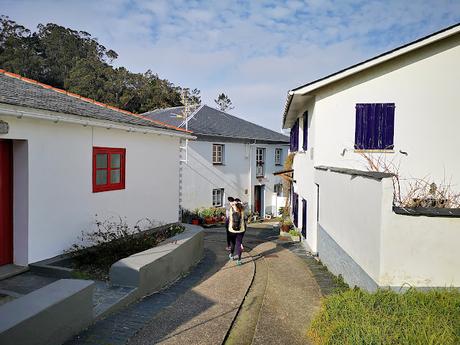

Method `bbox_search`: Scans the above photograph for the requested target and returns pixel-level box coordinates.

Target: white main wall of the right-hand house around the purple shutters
[294,34,460,250]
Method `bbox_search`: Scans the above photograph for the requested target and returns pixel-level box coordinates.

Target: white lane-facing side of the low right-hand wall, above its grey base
[315,170,382,282]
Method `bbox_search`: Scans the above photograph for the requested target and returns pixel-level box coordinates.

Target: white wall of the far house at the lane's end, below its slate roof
[181,140,288,213]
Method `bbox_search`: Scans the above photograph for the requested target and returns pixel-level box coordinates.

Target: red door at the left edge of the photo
[0,139,13,265]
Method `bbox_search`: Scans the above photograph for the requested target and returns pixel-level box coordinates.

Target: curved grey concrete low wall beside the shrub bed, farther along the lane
[110,224,204,297]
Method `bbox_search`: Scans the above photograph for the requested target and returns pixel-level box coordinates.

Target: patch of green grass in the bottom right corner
[308,289,460,345]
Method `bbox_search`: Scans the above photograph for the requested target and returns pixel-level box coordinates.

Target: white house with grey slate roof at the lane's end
[143,105,289,216]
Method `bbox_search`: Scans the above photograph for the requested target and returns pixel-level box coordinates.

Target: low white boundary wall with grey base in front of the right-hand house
[315,167,460,291]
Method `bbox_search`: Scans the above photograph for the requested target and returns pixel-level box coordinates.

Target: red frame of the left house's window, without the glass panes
[93,147,126,193]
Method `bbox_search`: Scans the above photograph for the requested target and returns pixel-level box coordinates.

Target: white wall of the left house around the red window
[0,111,179,264]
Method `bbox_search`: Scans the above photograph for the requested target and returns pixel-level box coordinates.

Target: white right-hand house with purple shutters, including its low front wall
[283,24,460,290]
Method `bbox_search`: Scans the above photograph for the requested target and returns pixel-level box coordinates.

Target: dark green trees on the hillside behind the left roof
[0,16,200,113]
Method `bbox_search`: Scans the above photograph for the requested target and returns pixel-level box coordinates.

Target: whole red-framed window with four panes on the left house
[93,147,126,193]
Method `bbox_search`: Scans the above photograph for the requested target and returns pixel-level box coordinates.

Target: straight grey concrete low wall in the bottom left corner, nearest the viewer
[0,279,94,345]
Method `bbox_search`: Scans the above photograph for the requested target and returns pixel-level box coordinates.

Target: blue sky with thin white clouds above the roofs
[0,0,460,131]
